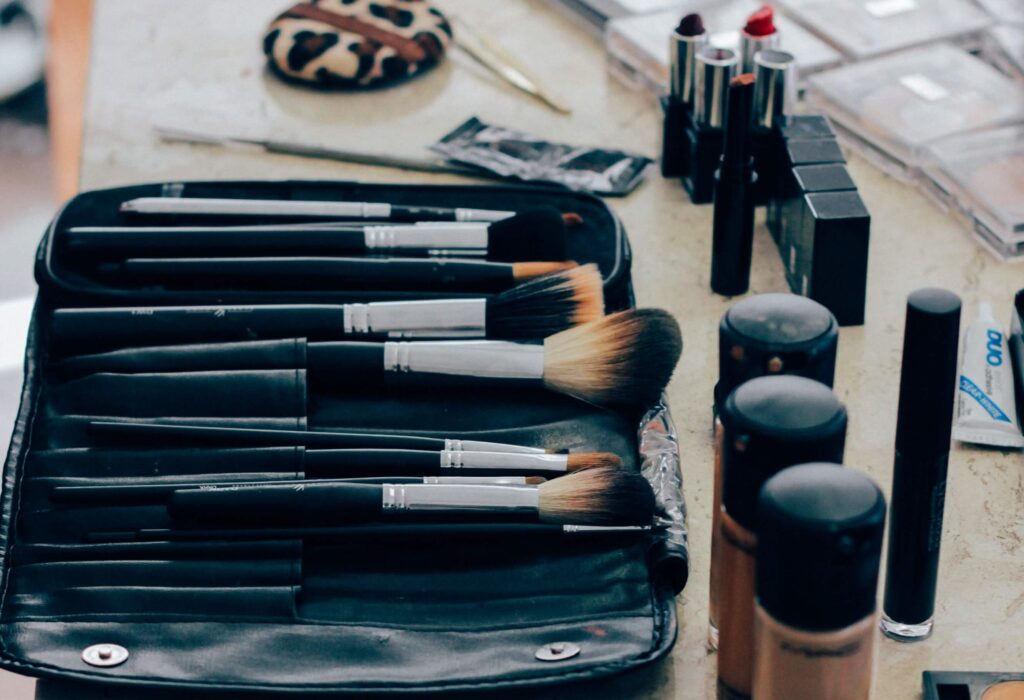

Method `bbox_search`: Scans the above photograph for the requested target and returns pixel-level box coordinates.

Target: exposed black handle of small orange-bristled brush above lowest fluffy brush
[305,449,441,479]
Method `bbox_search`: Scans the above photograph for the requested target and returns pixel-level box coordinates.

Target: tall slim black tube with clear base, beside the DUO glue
[882,289,961,642]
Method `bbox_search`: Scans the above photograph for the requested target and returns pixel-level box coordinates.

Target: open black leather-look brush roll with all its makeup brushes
[0,182,687,692]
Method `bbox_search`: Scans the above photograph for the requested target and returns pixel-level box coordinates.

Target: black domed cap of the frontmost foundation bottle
[757,464,886,630]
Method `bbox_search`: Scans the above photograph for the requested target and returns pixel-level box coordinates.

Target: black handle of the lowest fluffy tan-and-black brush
[167,483,382,527]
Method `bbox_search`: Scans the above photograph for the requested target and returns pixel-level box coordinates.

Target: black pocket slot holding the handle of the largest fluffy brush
[50,338,306,381]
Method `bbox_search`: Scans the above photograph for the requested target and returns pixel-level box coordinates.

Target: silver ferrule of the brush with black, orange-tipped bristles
[342,299,487,338]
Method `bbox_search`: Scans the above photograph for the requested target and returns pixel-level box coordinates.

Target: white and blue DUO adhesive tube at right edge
[953,304,1024,447]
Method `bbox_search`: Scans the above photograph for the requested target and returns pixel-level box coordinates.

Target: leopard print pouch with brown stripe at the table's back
[263,0,452,88]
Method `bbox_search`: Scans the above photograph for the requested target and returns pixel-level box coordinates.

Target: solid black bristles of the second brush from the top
[487,207,568,262]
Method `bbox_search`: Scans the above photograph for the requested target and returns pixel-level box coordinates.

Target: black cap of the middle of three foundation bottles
[721,377,846,532]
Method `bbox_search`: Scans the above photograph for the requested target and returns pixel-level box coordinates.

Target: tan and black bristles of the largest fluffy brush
[544,309,683,406]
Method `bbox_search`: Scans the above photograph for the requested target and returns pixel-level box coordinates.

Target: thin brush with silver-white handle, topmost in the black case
[121,196,515,221]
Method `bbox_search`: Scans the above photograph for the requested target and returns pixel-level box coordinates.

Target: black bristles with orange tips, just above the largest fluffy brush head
[486,263,604,340]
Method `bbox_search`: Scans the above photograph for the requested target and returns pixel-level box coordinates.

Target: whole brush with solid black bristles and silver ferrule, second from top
[65,207,574,262]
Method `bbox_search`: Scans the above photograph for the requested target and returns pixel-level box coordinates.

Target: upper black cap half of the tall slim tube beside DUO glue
[896,289,961,456]
